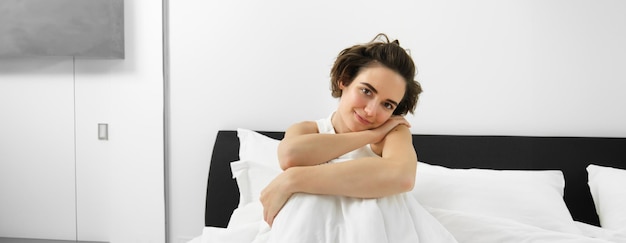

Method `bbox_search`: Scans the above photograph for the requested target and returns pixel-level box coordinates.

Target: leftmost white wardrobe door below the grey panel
[0,57,76,240]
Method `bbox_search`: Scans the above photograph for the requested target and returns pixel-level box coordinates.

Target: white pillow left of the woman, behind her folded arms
[230,128,282,207]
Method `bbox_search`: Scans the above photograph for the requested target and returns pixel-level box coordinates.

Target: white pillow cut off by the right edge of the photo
[587,164,626,230]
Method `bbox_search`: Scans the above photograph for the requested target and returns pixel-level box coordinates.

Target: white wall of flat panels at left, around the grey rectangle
[0,0,165,243]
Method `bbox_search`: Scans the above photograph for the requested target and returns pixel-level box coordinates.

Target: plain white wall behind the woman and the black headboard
[169,0,626,242]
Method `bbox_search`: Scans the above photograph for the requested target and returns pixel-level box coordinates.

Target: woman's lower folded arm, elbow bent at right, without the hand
[285,126,417,198]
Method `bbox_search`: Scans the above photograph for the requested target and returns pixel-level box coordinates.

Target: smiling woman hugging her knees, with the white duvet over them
[261,34,454,242]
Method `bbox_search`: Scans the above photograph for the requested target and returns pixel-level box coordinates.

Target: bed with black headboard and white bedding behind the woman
[194,129,626,242]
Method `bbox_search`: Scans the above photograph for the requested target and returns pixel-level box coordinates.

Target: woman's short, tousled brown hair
[330,33,422,115]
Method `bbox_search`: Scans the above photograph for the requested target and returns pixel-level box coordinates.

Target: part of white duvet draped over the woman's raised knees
[269,191,456,243]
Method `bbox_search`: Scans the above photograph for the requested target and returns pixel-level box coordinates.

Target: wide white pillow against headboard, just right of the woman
[412,162,580,233]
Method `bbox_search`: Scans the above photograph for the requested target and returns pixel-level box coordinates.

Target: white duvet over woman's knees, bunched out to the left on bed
[196,194,457,243]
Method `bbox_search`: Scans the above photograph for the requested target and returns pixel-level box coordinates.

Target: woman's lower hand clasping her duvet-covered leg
[260,168,294,227]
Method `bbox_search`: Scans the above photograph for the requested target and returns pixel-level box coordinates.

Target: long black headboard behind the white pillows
[205,130,626,227]
